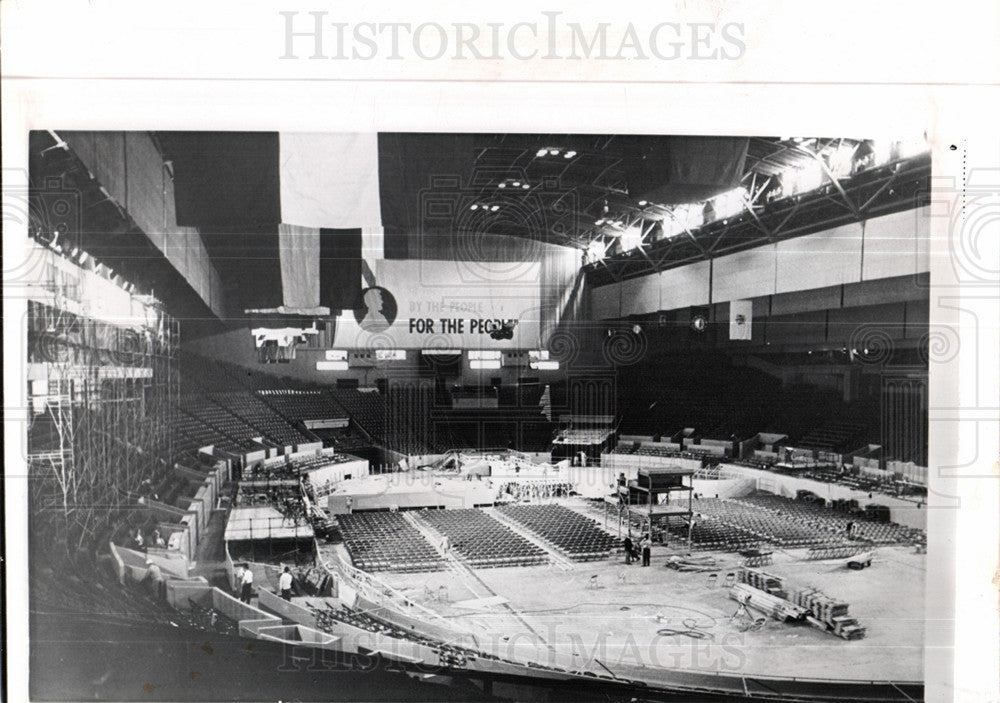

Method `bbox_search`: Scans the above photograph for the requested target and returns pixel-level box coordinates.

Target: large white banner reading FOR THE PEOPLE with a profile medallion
[334,259,541,349]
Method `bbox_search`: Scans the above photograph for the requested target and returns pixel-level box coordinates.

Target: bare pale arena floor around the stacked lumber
[380,547,934,682]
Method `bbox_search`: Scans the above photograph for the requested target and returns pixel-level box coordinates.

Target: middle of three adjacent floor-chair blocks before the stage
[418,508,548,568]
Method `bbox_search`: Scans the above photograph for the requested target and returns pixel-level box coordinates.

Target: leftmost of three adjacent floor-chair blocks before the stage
[337,512,444,571]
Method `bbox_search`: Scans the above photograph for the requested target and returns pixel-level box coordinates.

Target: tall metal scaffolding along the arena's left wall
[27,298,180,555]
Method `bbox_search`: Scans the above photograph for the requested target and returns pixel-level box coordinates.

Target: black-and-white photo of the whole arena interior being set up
[25,130,933,701]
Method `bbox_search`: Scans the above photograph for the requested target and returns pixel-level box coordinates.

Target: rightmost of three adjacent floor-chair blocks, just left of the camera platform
[498,505,619,561]
